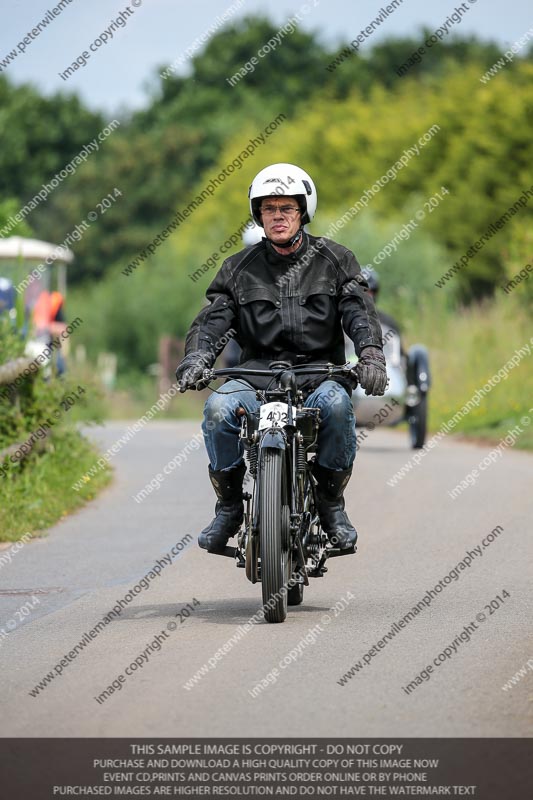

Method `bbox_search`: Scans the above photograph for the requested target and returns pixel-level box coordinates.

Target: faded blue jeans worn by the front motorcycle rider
[202,380,356,471]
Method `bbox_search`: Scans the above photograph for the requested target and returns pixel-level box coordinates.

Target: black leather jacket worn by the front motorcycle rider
[185,232,382,391]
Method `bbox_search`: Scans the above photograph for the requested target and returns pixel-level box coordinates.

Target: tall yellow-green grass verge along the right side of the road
[405,296,533,450]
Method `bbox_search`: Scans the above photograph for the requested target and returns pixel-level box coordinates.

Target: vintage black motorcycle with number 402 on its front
[189,361,356,623]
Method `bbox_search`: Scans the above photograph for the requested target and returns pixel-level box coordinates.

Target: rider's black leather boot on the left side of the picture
[198,462,246,553]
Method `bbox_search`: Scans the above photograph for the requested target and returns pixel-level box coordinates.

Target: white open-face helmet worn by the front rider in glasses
[248,164,317,225]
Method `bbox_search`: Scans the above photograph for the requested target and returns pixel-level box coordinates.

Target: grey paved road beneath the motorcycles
[0,422,533,737]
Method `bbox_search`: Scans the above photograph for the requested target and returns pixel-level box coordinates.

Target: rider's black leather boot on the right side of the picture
[313,461,357,550]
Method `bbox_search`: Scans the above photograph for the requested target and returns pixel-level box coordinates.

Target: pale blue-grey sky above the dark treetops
[0,0,533,114]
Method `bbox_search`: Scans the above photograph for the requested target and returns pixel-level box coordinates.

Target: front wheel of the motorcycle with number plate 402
[258,449,289,622]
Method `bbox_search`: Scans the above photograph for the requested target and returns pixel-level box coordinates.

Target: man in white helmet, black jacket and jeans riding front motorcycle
[176,164,387,552]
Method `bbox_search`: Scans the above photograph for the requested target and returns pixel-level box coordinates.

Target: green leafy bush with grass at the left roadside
[0,315,110,540]
